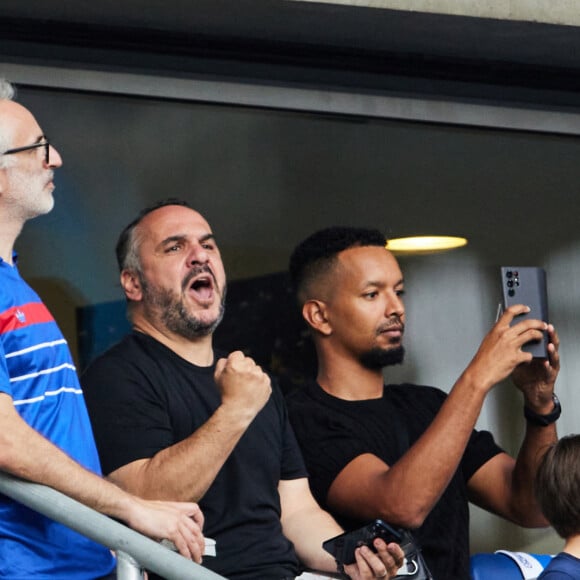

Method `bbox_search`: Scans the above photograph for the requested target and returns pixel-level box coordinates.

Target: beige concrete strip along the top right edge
[292,0,580,26]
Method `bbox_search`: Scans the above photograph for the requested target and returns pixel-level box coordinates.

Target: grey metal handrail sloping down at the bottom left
[0,471,225,580]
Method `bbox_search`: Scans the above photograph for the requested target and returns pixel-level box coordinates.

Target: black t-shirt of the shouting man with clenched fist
[81,332,306,580]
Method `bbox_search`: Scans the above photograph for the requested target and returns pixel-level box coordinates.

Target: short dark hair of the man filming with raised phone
[289,226,387,303]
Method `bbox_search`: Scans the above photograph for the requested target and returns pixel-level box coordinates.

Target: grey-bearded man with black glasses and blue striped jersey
[0,79,204,580]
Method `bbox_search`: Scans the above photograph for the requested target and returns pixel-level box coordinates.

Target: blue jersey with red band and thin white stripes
[0,259,114,580]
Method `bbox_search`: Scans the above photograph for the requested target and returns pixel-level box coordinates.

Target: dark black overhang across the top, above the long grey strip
[0,0,580,108]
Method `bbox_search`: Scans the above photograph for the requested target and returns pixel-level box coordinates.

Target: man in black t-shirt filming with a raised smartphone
[288,227,559,580]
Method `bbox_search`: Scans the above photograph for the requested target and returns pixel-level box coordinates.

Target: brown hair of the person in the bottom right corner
[534,435,580,538]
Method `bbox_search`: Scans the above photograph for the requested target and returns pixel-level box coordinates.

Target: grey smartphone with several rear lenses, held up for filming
[501,266,549,358]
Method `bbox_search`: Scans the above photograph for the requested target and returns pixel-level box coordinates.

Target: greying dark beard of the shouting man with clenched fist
[141,279,226,340]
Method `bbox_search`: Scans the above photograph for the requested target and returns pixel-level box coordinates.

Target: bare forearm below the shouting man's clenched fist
[108,406,251,502]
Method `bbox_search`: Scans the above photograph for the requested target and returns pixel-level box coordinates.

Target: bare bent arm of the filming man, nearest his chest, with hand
[328,305,557,528]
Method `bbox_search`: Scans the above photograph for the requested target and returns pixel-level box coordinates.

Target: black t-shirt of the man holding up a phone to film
[287,384,501,580]
